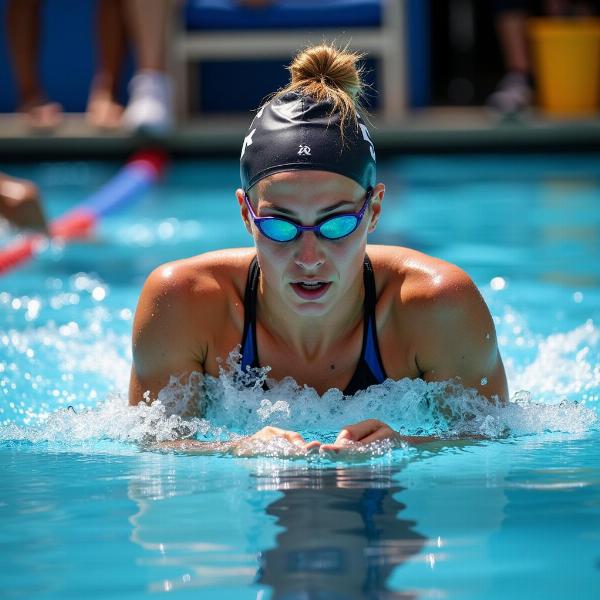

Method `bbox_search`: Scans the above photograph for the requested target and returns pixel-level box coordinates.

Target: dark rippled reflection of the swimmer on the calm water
[256,466,425,600]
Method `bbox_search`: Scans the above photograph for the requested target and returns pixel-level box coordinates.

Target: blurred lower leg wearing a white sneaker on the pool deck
[124,0,173,132]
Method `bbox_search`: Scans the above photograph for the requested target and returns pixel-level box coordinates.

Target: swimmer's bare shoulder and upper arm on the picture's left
[129,249,254,404]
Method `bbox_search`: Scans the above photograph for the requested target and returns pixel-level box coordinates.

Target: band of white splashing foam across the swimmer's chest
[0,346,597,457]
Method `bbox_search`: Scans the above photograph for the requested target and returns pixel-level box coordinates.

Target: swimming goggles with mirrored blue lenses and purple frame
[244,188,373,242]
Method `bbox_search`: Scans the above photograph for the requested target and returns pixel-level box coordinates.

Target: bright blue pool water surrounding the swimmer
[0,155,600,600]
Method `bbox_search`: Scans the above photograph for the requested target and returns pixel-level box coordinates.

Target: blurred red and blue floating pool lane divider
[0,150,167,275]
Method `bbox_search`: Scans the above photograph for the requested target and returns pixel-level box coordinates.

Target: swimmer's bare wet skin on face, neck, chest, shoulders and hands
[129,171,508,452]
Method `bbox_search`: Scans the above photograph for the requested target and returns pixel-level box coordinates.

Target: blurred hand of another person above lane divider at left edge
[0,173,48,233]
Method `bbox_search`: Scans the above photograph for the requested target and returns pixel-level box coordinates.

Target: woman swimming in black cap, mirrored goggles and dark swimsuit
[129,44,508,452]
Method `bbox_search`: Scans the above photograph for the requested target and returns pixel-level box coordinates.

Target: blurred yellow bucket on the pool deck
[528,18,600,117]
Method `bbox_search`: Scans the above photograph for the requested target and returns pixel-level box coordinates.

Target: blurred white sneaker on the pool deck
[123,71,173,133]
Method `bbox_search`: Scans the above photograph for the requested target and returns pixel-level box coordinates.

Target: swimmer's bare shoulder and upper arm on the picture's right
[368,246,508,399]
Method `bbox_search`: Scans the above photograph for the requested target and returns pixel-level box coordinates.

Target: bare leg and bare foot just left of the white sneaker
[87,0,125,129]
